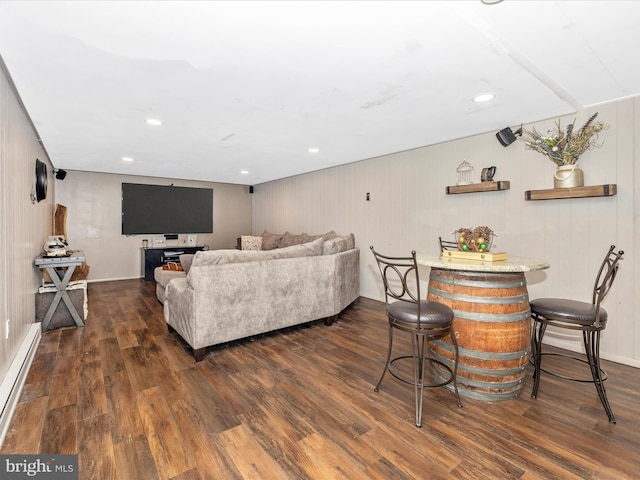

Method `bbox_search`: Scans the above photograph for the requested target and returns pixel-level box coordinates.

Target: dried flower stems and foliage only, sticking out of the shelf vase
[522,112,608,166]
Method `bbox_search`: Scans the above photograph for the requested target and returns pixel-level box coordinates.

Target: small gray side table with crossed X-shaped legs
[34,250,86,332]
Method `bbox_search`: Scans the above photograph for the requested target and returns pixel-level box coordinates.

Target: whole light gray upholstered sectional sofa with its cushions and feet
[155,232,360,361]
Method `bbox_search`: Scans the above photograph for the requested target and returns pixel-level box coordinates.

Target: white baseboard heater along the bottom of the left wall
[0,323,41,447]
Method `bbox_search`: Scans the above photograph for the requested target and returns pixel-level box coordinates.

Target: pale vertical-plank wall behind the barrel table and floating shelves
[252,97,640,367]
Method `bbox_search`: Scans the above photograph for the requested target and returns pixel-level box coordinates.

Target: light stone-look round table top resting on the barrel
[416,253,549,272]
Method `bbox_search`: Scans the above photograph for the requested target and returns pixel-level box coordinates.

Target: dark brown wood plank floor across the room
[1,280,640,480]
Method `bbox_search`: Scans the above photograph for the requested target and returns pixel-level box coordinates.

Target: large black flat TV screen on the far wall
[122,183,213,235]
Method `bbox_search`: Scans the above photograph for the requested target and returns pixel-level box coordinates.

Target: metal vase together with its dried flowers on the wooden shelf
[522,112,607,188]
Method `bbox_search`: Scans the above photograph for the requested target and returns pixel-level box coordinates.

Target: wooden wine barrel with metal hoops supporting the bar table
[427,267,531,401]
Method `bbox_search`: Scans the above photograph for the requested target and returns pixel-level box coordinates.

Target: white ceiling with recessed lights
[0,0,640,185]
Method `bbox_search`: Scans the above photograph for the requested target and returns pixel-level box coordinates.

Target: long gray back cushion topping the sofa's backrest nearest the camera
[192,238,323,267]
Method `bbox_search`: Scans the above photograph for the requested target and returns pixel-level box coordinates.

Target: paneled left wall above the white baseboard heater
[0,58,55,398]
